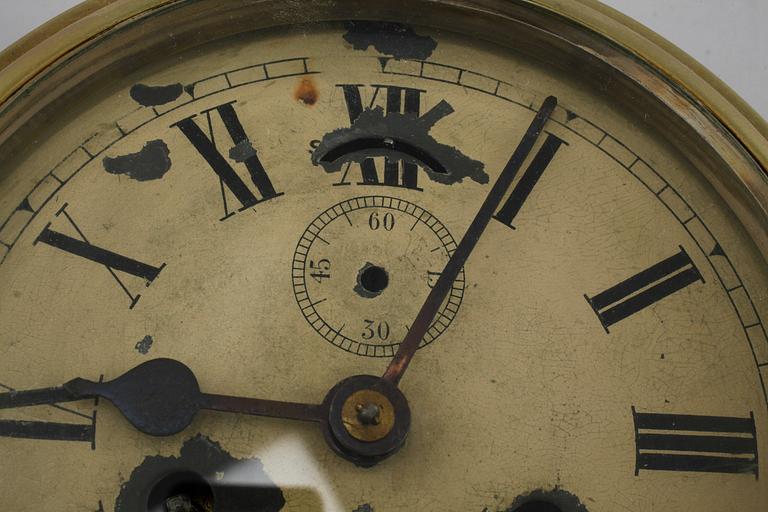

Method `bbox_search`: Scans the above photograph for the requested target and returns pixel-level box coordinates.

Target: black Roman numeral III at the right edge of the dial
[632,407,759,477]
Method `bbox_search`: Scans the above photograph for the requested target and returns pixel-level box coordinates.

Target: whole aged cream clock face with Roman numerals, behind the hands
[0,2,768,512]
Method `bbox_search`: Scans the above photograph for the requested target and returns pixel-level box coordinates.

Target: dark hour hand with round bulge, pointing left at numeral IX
[0,359,322,436]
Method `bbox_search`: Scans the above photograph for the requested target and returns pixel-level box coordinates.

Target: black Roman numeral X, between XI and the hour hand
[35,203,165,308]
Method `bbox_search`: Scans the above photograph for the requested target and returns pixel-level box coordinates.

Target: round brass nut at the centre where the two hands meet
[341,389,395,442]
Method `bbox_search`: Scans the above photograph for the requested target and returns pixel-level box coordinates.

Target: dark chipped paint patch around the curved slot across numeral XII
[312,100,490,185]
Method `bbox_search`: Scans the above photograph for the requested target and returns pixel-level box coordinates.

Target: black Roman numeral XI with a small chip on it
[173,102,283,220]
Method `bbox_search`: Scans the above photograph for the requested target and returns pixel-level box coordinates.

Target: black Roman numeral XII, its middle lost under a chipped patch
[335,84,426,190]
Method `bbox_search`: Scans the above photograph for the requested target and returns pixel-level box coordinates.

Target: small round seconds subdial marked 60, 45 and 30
[292,196,464,357]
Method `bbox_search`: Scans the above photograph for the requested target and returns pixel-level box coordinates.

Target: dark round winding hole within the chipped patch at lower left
[147,471,213,512]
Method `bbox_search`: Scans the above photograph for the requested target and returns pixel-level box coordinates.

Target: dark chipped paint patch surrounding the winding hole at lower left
[115,434,285,512]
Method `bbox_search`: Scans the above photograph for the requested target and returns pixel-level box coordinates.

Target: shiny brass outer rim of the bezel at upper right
[536,0,768,178]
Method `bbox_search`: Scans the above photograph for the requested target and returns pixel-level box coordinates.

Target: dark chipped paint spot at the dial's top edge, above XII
[344,21,437,60]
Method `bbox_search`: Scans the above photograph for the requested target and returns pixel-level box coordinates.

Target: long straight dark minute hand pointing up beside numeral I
[382,96,557,386]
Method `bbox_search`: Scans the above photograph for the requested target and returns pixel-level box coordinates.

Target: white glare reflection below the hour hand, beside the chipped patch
[223,434,344,511]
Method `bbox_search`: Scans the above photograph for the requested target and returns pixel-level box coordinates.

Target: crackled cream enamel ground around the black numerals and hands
[0,12,768,512]
